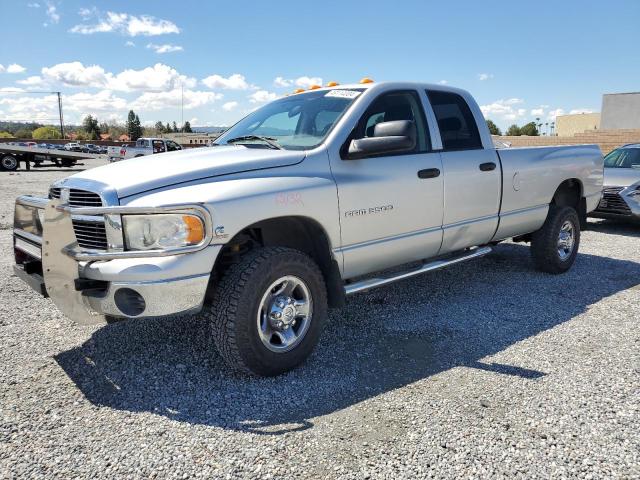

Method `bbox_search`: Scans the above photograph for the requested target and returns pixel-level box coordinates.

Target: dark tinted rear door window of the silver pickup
[427,90,482,150]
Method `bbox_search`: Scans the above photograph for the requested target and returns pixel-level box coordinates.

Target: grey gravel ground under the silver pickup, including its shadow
[0,163,640,478]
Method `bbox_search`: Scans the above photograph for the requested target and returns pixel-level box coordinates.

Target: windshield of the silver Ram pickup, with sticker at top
[216,89,363,150]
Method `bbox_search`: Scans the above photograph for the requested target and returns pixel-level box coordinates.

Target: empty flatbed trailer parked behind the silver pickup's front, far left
[0,144,104,171]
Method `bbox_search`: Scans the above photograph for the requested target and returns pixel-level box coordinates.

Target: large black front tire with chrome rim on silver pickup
[208,247,327,376]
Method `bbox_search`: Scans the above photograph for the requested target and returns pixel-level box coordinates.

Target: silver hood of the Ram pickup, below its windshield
[69,145,306,198]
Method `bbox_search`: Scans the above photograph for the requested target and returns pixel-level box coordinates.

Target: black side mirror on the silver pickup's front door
[347,120,417,160]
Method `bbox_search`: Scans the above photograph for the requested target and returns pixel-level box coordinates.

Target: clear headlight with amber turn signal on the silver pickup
[122,213,205,250]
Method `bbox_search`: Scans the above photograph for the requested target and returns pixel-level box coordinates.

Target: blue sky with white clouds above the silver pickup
[0,0,640,128]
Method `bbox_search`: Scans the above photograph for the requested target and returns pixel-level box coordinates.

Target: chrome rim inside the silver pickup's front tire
[257,275,313,353]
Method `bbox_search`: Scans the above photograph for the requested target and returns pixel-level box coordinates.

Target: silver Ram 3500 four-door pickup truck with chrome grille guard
[14,82,603,375]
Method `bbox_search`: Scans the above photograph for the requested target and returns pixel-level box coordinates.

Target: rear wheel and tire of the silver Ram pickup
[531,205,580,274]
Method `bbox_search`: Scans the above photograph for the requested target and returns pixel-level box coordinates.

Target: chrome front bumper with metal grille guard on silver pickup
[14,197,221,325]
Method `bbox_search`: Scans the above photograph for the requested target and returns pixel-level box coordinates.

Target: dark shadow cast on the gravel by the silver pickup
[56,244,640,435]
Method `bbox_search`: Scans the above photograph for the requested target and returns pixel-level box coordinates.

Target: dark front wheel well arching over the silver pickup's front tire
[212,217,345,307]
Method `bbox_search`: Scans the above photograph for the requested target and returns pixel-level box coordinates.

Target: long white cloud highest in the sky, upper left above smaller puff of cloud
[69,12,180,37]
